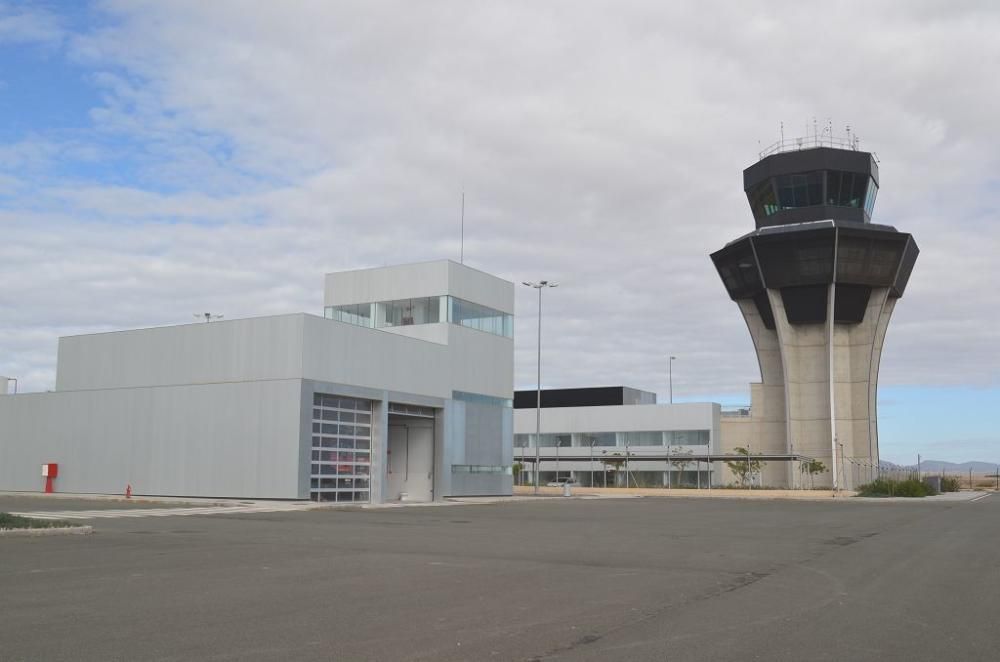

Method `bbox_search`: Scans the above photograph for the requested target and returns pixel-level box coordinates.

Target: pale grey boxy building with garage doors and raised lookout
[0,260,514,503]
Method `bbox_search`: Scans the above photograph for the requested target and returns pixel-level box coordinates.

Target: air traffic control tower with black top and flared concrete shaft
[712,140,919,489]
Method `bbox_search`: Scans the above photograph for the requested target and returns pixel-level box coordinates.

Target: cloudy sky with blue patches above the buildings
[0,0,1000,462]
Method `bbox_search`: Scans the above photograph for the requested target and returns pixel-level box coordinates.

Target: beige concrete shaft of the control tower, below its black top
[722,288,896,489]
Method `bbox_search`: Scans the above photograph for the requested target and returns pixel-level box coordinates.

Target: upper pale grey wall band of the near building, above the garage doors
[56,314,514,398]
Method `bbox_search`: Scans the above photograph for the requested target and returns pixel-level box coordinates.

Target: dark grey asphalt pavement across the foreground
[0,496,1000,662]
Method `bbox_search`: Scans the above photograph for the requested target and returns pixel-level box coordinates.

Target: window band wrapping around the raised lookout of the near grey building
[324,295,514,338]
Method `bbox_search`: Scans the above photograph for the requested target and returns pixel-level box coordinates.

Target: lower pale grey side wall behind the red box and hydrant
[0,379,308,499]
